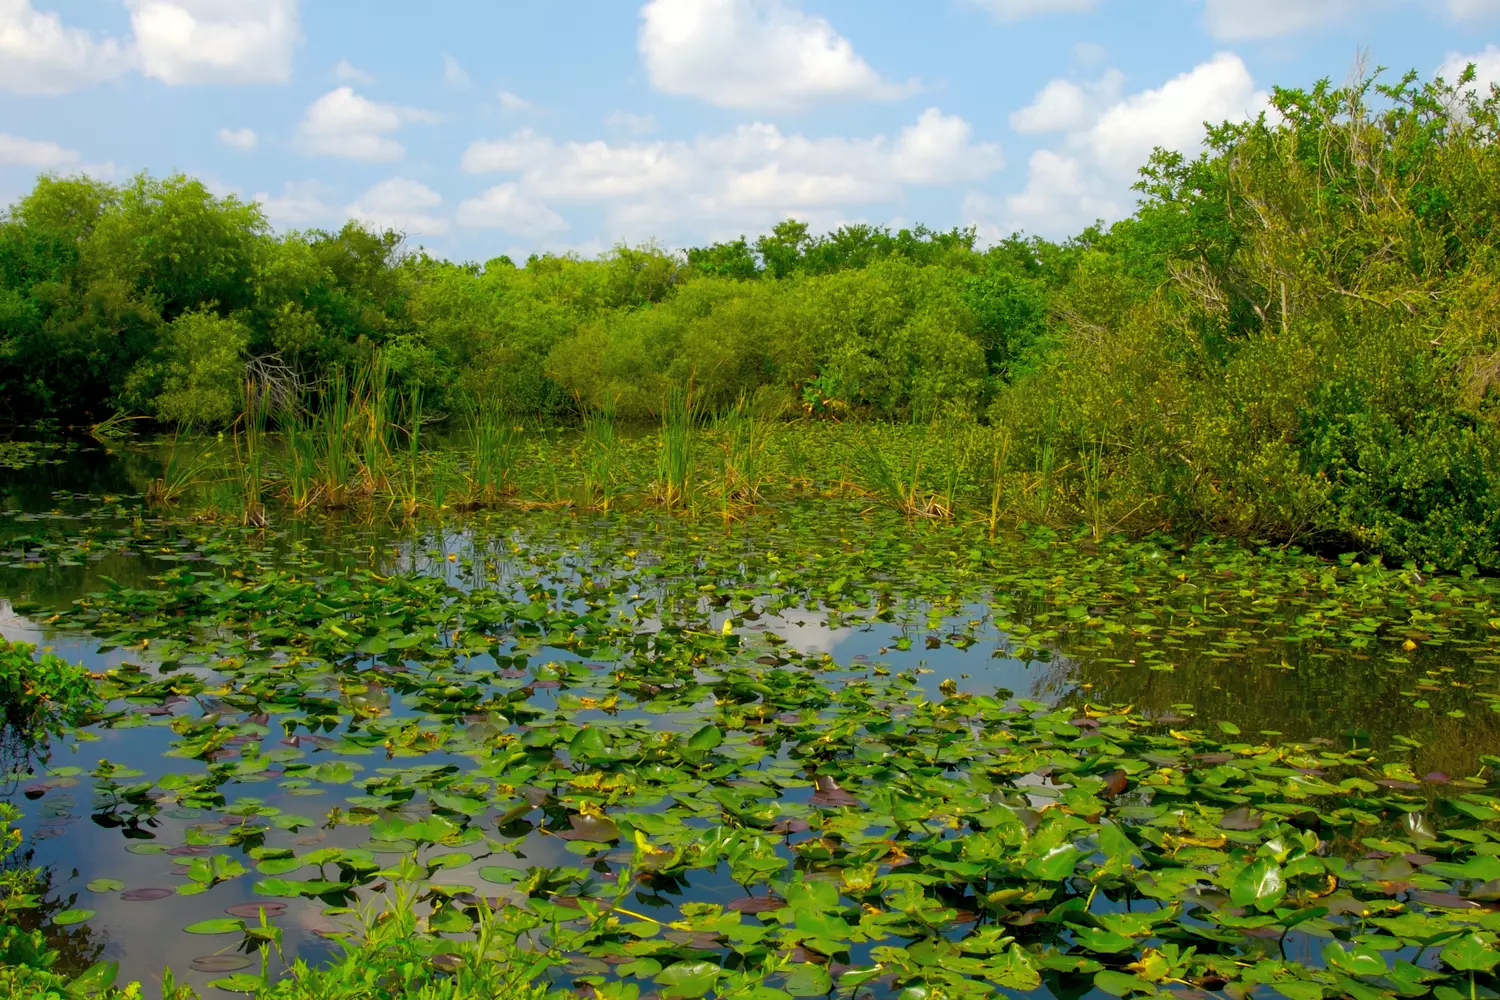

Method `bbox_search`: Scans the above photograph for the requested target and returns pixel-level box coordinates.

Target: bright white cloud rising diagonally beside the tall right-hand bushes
[992,52,1266,235]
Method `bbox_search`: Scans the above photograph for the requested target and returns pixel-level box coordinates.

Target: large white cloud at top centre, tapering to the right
[639,0,914,108]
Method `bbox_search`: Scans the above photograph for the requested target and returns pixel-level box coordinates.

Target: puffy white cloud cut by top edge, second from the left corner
[128,0,302,84]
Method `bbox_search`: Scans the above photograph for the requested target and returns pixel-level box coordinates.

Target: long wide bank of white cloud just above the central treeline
[461,108,1004,238]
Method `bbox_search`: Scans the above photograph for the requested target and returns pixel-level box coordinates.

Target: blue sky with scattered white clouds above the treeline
[0,0,1500,261]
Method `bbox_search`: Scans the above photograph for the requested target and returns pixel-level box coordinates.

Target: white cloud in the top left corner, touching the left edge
[0,0,129,94]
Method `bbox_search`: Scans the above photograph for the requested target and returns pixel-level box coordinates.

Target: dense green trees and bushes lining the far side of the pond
[0,66,1500,568]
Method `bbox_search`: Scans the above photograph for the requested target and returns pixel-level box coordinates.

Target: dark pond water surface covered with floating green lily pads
[0,454,1500,1000]
